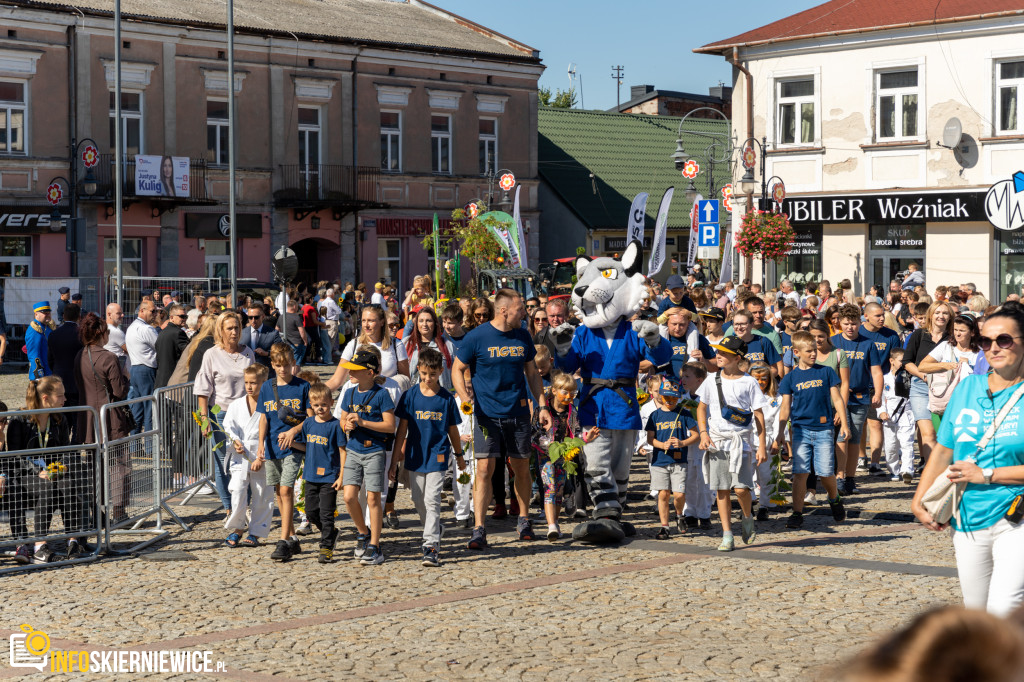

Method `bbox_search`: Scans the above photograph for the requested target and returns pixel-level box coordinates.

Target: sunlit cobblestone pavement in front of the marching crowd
[0,366,959,681]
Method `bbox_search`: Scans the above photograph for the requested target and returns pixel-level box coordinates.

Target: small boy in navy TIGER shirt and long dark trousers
[285,383,346,563]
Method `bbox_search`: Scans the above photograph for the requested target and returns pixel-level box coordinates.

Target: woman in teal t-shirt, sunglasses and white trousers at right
[911,302,1024,615]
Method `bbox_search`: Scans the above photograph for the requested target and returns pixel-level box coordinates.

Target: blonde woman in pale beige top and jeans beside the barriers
[193,310,256,513]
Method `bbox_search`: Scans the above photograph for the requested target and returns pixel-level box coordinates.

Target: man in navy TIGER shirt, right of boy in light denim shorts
[831,303,882,495]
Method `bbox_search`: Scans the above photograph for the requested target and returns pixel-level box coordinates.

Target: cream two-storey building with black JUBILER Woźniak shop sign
[696,0,1024,300]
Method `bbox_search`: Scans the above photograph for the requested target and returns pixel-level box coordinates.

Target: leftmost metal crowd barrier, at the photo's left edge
[0,407,103,574]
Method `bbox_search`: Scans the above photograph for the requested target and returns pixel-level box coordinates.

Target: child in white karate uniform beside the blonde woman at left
[223,365,273,547]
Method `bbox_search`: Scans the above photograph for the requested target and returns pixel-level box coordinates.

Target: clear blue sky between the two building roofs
[431,0,824,109]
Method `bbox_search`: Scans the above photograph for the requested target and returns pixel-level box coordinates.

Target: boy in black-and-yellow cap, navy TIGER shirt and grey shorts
[341,350,395,566]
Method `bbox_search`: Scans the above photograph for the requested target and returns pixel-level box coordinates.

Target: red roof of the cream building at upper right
[693,0,1024,54]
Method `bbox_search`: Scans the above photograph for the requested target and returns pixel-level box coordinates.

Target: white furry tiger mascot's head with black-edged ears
[572,240,648,329]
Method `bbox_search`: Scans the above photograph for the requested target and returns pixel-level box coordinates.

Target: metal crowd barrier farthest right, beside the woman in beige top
[154,382,219,518]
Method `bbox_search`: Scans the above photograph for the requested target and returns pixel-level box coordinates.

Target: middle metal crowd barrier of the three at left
[99,395,175,554]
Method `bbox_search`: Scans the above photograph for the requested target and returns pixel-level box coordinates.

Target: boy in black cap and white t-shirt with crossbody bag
[697,336,768,552]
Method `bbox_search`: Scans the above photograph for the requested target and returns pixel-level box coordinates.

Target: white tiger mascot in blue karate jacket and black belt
[555,241,672,543]
